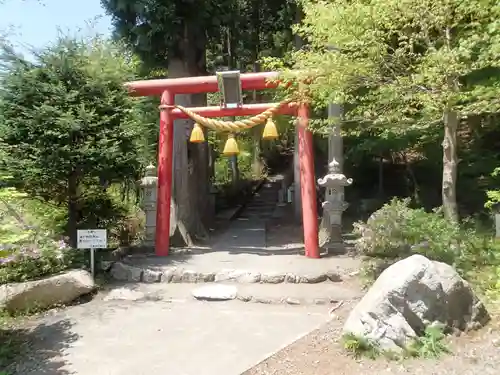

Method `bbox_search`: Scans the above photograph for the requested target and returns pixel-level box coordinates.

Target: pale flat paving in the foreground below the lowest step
[9,299,329,375]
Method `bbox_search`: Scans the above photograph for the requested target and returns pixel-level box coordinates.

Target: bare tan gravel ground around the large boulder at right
[242,302,500,375]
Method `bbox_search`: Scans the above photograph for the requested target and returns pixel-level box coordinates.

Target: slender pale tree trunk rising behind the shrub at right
[442,110,458,222]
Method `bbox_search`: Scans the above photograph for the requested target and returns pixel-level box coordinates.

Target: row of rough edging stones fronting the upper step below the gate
[106,262,342,284]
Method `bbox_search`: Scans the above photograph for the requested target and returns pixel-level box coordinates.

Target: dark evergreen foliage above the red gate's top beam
[101,0,296,71]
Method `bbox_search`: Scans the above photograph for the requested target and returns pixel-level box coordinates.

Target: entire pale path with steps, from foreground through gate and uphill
[8,176,361,375]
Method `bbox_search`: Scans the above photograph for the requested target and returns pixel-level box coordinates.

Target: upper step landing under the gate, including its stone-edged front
[110,253,360,284]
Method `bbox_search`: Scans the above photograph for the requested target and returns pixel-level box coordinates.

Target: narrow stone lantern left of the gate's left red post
[140,164,158,247]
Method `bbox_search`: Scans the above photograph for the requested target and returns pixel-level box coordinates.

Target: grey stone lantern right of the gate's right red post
[318,158,352,249]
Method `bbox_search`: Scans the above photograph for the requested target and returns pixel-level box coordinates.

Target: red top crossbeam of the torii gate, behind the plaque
[125,72,278,96]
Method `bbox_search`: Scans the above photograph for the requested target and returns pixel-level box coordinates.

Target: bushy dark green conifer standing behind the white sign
[0,38,148,242]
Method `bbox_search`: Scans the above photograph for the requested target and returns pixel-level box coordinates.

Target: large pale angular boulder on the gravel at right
[344,255,489,351]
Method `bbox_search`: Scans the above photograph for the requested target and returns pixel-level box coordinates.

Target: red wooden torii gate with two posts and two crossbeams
[125,72,320,258]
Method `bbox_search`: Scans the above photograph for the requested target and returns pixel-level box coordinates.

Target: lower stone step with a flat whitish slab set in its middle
[103,283,363,306]
